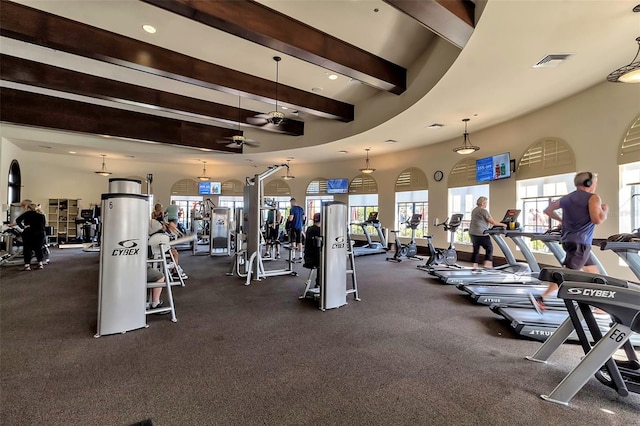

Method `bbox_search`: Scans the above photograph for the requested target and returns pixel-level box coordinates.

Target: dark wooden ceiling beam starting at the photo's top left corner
[0,0,354,122]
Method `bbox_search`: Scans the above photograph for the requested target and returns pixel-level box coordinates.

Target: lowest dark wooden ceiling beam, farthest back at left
[0,87,240,153]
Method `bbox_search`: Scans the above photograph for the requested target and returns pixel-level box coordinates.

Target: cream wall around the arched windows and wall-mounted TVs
[0,82,640,279]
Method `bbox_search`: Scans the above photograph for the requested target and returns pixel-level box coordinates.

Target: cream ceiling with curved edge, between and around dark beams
[0,0,640,168]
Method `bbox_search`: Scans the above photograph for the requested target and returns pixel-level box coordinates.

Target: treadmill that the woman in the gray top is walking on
[429,209,540,285]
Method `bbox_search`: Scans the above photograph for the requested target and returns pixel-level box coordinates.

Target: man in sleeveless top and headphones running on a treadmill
[529,172,609,313]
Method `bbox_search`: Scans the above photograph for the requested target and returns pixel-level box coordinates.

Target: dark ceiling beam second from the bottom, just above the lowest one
[0,54,304,136]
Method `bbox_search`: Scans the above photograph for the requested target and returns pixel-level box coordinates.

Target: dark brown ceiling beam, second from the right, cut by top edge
[142,0,407,95]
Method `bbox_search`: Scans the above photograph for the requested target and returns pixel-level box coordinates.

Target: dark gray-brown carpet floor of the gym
[0,249,640,426]
